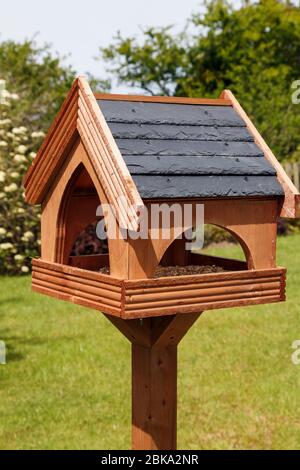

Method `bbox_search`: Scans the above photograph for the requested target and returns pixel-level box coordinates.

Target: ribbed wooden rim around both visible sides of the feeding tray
[32,259,286,319]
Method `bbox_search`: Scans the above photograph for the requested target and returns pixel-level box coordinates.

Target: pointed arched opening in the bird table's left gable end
[56,164,109,271]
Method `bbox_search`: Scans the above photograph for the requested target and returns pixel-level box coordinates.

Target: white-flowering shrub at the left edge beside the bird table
[0,80,44,274]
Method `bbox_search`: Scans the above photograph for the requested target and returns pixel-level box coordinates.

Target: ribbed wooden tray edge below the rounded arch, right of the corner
[124,268,285,318]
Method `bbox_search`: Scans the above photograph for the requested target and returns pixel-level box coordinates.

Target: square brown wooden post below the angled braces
[132,344,177,450]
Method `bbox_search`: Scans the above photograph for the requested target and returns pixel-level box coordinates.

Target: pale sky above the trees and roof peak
[0,0,209,92]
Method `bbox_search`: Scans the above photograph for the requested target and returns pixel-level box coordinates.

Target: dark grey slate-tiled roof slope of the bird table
[97,100,284,199]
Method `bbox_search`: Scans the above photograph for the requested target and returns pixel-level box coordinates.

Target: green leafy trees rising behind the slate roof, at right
[101,0,300,160]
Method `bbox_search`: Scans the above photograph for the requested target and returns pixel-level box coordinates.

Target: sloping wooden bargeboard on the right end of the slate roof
[221,90,300,218]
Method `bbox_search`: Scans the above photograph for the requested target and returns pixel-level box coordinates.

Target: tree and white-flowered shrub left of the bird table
[0,41,75,274]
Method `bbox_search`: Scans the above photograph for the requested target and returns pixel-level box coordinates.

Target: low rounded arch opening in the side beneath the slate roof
[154,224,249,277]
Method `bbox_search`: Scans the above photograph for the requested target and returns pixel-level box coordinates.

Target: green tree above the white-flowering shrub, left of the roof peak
[0,41,75,131]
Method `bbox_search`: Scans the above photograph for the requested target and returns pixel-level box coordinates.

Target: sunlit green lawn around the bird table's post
[0,235,300,449]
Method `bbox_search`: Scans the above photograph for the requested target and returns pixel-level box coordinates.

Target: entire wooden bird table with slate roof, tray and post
[24,78,299,449]
